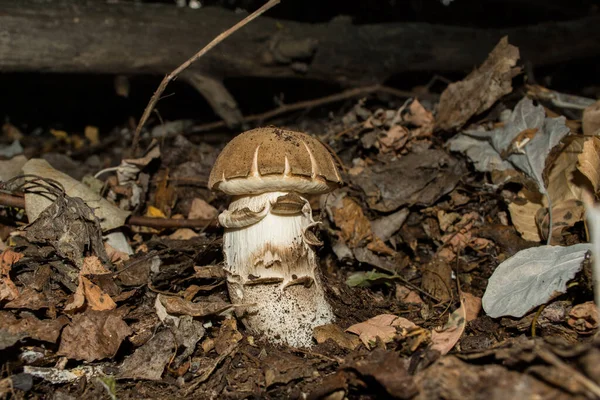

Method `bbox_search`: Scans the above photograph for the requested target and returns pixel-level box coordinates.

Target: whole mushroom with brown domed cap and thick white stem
[208,127,342,347]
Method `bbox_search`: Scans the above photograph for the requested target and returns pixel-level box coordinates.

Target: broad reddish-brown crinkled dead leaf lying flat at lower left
[58,310,132,362]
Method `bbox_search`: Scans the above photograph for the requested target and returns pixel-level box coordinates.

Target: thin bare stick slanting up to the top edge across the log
[131,0,280,154]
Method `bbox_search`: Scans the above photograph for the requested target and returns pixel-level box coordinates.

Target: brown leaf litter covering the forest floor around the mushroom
[0,33,600,399]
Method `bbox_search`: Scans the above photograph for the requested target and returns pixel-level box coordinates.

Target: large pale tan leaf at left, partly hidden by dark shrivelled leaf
[23,158,130,230]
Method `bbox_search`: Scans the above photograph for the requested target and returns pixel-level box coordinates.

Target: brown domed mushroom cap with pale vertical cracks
[208,127,342,195]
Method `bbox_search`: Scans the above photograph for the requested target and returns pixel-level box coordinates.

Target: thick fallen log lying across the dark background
[0,0,600,85]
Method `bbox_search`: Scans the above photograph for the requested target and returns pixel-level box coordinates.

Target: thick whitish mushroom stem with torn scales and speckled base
[219,192,334,347]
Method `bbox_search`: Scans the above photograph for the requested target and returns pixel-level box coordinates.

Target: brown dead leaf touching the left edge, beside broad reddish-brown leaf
[0,311,69,350]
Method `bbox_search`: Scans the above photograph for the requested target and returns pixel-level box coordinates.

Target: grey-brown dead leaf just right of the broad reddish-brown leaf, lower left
[119,329,177,381]
